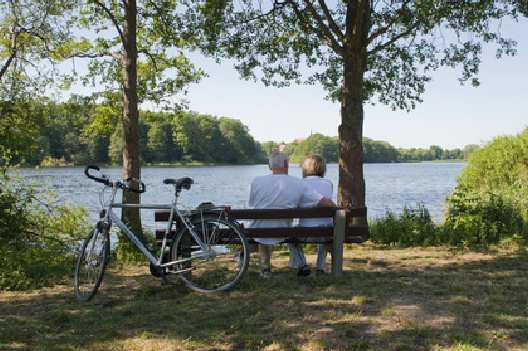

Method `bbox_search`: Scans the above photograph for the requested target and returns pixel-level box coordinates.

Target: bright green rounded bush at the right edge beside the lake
[444,128,528,245]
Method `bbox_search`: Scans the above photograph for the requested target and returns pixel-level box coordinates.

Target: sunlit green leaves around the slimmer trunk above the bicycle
[65,0,205,134]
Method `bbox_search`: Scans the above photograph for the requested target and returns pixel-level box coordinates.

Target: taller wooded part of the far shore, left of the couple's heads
[11,99,265,166]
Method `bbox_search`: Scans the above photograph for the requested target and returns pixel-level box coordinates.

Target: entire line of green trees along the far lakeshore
[11,102,478,166]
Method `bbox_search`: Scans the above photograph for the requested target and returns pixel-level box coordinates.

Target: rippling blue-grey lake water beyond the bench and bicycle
[14,163,466,222]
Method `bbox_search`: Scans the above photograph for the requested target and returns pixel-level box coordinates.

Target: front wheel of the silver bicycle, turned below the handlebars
[74,224,110,302]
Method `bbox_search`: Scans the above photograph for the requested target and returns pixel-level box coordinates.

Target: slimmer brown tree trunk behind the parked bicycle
[122,0,144,242]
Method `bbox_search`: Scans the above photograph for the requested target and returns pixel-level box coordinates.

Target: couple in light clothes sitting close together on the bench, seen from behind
[249,151,335,278]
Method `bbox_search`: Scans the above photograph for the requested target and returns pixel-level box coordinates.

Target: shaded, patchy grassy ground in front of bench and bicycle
[0,244,528,351]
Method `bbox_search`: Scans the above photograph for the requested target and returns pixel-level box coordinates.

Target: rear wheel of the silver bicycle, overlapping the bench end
[171,214,249,293]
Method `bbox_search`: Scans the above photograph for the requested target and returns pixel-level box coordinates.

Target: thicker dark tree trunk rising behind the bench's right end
[337,0,371,207]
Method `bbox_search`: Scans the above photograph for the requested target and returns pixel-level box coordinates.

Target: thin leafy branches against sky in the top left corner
[0,0,75,86]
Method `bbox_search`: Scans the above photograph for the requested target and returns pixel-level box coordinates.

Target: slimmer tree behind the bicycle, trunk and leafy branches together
[64,0,203,241]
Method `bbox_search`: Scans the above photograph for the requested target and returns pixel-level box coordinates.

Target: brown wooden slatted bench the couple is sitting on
[155,207,369,277]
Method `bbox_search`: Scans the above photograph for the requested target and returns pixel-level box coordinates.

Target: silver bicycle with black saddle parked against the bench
[74,165,249,301]
